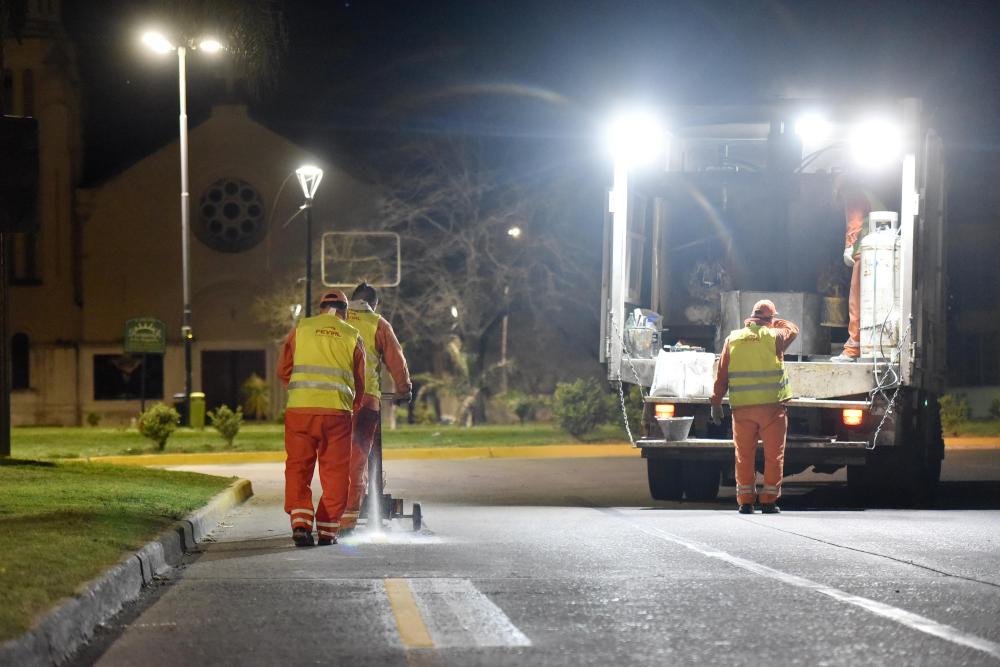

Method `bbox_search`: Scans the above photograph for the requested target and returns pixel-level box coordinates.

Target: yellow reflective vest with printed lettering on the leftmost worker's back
[288,313,359,412]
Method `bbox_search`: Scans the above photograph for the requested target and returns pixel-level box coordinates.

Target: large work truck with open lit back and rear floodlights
[601,98,947,505]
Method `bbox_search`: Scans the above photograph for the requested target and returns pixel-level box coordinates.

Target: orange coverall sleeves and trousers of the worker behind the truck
[712,318,799,505]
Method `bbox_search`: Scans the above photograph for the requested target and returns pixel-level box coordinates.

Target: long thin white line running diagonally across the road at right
[629,521,1000,658]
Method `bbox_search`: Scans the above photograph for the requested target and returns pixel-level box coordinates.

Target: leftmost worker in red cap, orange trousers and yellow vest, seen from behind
[278,290,365,547]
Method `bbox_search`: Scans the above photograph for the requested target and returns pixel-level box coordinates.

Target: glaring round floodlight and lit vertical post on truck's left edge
[606,110,664,382]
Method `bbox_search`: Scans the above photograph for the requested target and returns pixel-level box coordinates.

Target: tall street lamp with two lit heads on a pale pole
[142,31,222,426]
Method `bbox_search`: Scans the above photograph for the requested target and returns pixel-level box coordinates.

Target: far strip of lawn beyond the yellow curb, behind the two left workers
[11,423,625,459]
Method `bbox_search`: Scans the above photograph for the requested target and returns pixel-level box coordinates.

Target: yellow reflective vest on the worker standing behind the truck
[729,324,792,407]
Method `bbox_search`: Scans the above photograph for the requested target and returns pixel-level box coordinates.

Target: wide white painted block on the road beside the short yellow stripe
[407,579,531,648]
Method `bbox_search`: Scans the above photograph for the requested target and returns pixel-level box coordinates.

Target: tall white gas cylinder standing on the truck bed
[860,211,900,361]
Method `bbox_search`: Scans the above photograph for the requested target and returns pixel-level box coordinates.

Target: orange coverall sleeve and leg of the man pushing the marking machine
[340,310,413,528]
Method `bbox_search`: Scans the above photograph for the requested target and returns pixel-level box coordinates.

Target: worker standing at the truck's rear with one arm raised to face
[712,299,799,514]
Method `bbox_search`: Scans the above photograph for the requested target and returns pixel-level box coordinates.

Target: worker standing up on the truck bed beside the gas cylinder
[830,178,885,363]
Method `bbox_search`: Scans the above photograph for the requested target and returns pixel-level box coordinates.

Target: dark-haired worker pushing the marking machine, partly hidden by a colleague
[340,283,412,531]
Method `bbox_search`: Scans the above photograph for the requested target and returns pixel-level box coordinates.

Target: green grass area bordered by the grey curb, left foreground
[0,459,231,642]
